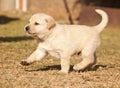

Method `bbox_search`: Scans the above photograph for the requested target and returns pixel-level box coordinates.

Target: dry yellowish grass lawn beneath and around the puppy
[0,14,120,88]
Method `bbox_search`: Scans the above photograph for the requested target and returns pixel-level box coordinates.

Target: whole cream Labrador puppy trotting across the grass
[21,9,108,73]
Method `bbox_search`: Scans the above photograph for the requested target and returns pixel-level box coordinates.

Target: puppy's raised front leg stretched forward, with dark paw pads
[21,49,46,66]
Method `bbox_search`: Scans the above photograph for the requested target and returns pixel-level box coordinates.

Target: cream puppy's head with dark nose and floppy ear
[25,13,56,39]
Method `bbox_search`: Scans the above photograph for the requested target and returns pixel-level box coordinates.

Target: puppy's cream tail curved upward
[94,9,108,33]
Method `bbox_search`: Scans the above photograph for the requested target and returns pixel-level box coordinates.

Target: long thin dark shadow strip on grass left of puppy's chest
[0,36,33,42]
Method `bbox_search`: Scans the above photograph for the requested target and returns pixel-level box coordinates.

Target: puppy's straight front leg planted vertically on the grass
[59,55,70,74]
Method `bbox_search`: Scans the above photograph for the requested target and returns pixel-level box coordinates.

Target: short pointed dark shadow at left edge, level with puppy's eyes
[0,15,20,24]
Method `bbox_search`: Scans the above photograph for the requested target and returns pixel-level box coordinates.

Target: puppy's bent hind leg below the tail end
[73,42,96,71]
